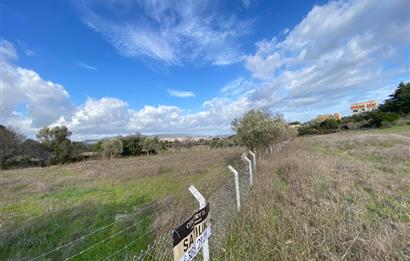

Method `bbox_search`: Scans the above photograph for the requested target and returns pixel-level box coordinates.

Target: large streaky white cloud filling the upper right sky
[245,0,410,110]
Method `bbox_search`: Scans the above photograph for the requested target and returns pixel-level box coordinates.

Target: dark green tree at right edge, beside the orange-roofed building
[380,82,410,115]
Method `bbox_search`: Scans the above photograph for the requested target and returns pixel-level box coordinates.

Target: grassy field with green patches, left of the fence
[0,149,240,260]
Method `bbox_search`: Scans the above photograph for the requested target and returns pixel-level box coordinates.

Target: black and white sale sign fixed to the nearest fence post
[172,203,211,261]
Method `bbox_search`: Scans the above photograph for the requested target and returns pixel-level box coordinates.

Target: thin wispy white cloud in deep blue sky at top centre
[76,0,250,65]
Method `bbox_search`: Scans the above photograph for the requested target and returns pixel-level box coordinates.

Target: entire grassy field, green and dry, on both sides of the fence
[0,126,410,260]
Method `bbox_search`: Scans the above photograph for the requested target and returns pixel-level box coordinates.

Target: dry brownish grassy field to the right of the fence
[216,125,410,260]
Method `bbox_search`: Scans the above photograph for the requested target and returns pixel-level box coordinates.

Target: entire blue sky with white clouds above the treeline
[0,0,410,140]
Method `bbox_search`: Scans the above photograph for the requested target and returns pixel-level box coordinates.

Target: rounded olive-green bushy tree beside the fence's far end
[232,109,290,149]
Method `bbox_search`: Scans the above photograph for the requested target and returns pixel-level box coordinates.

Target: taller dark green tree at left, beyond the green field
[37,126,72,163]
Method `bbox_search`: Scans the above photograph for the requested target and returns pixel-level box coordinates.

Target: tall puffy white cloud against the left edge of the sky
[0,40,74,128]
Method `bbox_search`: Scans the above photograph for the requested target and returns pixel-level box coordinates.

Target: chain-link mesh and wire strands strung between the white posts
[29,141,286,261]
